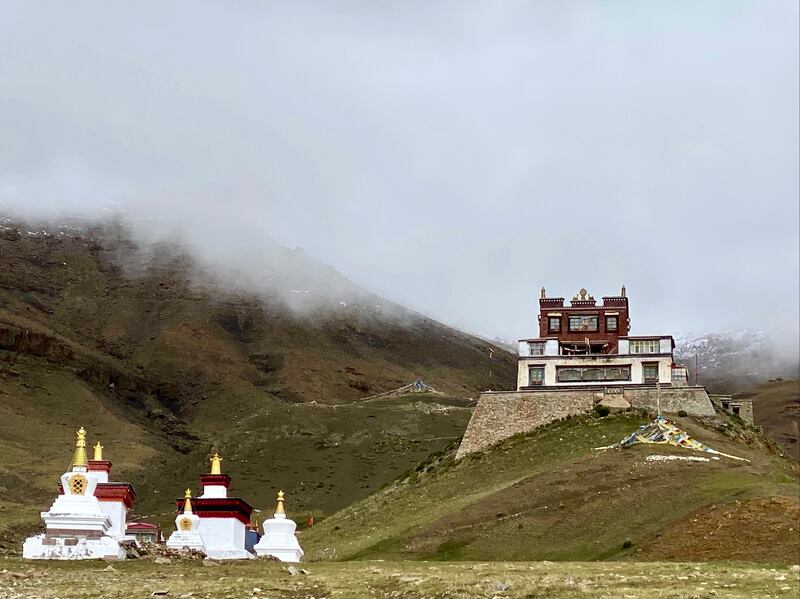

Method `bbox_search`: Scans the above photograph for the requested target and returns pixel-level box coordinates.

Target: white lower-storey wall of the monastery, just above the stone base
[517,354,672,390]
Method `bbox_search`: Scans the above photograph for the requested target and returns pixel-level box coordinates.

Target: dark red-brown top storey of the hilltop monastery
[539,287,630,354]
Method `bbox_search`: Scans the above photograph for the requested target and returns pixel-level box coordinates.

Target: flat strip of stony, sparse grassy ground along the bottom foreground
[0,559,800,599]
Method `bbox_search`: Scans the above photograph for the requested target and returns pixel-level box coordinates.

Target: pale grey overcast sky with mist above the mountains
[0,0,800,339]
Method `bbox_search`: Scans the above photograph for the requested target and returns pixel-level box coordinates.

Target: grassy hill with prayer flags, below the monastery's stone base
[303,414,800,563]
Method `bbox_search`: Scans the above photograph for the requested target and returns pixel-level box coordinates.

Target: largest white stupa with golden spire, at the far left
[22,427,125,559]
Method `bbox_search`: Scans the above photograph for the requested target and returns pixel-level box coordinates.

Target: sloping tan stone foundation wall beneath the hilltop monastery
[456,387,715,459]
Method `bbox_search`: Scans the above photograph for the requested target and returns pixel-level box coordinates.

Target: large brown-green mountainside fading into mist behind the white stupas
[0,223,515,548]
